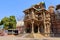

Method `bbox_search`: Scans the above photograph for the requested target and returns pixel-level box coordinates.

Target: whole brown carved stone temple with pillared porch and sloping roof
[24,2,60,36]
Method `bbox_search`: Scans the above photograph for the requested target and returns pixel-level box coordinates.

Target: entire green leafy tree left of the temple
[0,16,16,29]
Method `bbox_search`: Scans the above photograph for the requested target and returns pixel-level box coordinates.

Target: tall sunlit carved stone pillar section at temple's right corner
[43,13,50,37]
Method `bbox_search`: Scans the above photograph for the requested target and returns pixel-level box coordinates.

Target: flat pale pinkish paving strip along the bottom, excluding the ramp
[0,36,60,40]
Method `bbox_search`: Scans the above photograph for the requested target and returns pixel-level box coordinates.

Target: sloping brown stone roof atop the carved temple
[23,2,45,13]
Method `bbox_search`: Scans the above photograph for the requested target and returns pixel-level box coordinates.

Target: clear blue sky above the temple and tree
[0,0,60,20]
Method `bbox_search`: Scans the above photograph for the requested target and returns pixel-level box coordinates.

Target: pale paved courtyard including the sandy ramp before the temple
[0,34,60,40]
